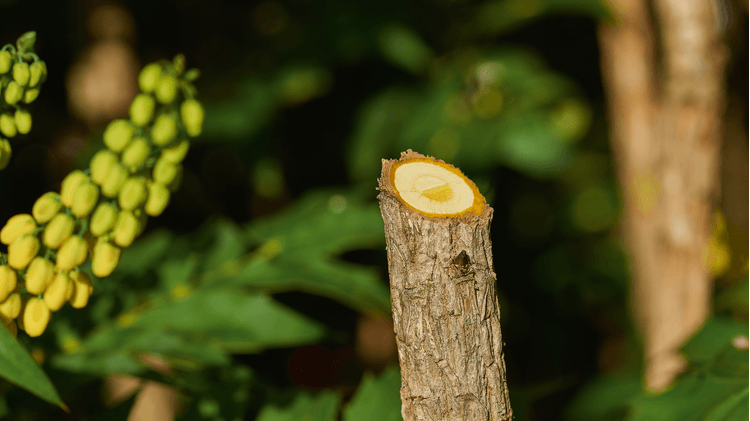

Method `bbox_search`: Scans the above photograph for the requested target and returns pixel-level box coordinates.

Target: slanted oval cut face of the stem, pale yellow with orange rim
[391,158,484,218]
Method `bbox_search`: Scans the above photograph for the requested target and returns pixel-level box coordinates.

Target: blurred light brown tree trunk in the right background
[599,0,726,390]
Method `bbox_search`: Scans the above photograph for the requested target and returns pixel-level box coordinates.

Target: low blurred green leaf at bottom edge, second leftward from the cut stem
[256,391,340,421]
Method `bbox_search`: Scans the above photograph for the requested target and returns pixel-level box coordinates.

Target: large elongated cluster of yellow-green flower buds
[0,56,204,337]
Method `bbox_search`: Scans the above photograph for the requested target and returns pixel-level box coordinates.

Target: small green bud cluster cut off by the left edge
[0,32,47,170]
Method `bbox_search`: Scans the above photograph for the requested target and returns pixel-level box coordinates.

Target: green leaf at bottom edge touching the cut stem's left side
[342,366,402,421]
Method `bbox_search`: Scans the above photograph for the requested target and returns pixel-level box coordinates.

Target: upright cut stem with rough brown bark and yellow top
[378,150,513,421]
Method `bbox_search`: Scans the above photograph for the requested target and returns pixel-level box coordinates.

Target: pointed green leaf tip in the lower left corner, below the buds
[0,329,66,409]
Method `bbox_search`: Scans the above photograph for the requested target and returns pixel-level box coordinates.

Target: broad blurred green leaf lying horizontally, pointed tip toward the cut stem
[135,290,325,352]
